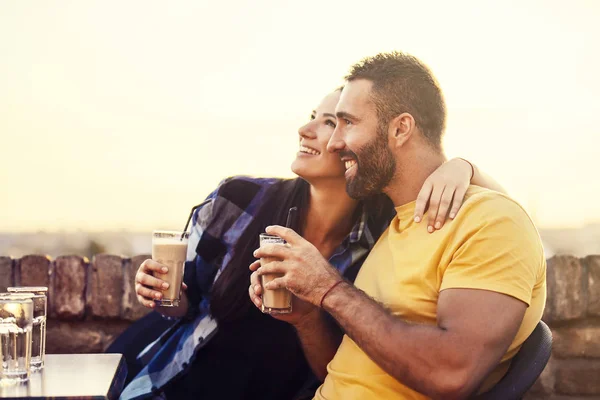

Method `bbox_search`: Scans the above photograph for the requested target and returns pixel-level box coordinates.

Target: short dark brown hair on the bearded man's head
[346,51,446,150]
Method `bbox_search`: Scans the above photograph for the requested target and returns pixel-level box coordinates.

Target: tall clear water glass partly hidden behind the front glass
[6,286,48,371]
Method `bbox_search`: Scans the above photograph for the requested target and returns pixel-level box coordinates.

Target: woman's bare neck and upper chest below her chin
[302,182,358,255]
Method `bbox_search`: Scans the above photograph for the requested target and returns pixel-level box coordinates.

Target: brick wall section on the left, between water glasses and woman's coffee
[0,254,150,353]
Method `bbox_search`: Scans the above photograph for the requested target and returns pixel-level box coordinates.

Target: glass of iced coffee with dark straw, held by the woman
[152,231,189,307]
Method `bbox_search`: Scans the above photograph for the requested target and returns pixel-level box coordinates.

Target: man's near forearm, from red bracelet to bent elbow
[323,283,478,398]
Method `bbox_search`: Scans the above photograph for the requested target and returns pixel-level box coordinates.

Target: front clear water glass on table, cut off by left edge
[0,296,33,385]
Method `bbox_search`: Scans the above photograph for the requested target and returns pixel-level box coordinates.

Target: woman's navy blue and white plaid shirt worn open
[120,177,393,399]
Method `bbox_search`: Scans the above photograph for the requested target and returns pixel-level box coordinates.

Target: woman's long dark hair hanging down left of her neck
[210,179,309,323]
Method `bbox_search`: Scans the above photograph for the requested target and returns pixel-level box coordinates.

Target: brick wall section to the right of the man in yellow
[527,256,600,400]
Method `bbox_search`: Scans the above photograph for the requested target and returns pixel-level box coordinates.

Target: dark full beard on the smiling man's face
[346,124,396,199]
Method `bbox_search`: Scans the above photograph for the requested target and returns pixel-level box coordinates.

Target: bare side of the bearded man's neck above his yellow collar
[384,149,446,207]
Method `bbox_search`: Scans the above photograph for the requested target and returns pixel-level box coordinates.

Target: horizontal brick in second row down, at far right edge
[552,326,600,358]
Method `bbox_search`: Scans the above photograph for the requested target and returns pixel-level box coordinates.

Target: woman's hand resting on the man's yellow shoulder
[414,158,474,233]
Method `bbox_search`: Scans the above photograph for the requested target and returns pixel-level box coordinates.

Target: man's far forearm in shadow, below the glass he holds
[295,310,342,381]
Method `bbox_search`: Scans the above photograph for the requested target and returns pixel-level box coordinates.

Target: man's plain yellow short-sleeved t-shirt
[315,186,546,400]
